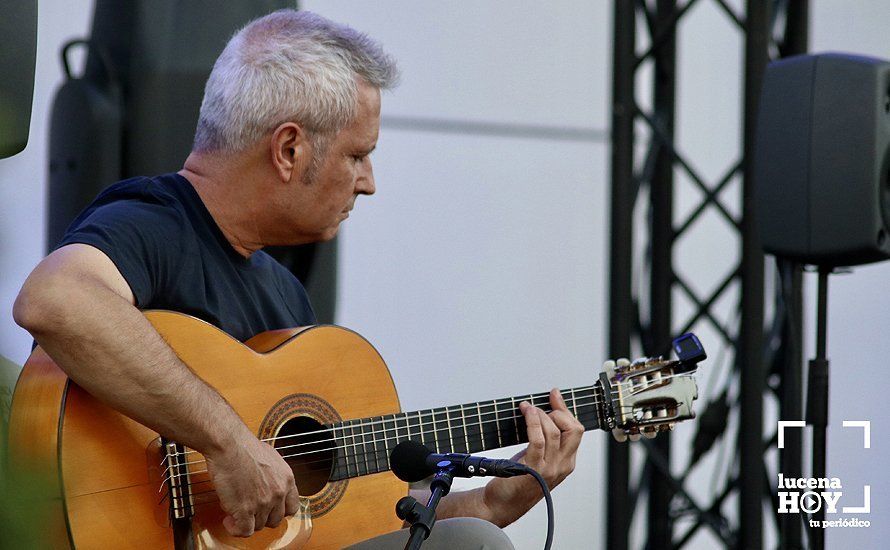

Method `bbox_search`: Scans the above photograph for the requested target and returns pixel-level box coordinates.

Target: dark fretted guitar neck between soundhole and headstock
[329,382,606,480]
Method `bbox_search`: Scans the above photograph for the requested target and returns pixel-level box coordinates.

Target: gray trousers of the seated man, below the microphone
[348,518,513,550]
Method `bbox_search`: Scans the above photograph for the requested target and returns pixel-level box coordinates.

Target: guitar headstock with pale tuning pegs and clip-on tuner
[600,333,707,440]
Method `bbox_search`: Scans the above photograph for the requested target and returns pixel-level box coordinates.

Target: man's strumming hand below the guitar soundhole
[205,434,300,537]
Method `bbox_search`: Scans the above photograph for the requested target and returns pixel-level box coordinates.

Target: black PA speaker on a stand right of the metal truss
[754,53,890,266]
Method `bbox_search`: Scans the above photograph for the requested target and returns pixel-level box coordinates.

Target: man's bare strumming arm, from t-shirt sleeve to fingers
[13,244,298,536]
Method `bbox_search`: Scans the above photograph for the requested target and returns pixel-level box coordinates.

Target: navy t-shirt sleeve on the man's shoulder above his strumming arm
[56,201,183,308]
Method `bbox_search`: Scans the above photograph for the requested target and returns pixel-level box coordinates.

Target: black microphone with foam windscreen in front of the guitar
[389,441,531,483]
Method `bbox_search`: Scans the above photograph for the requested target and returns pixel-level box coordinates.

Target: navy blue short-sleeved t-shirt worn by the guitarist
[58,174,316,341]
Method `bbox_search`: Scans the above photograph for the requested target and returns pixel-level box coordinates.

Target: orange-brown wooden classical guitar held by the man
[9,311,703,549]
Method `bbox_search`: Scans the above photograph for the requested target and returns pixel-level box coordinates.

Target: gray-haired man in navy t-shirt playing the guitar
[14,10,583,548]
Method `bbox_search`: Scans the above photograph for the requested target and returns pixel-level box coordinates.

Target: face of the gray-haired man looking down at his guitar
[291,83,380,241]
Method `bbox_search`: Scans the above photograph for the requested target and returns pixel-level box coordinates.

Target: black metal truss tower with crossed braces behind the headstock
[606,0,809,550]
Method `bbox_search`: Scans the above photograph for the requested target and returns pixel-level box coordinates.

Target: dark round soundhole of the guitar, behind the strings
[274,416,336,496]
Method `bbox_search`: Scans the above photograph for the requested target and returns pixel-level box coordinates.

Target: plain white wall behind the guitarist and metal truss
[0,0,890,549]
